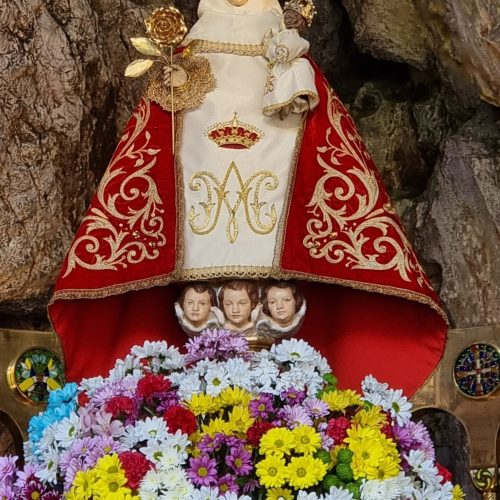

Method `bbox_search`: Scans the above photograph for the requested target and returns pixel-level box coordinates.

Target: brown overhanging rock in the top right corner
[342,0,500,109]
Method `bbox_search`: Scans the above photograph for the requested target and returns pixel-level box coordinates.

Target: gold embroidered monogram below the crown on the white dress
[188,162,278,244]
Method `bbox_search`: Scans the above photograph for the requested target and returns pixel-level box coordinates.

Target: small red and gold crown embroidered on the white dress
[206,111,264,149]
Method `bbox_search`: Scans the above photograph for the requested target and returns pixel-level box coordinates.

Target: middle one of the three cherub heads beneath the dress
[219,280,259,330]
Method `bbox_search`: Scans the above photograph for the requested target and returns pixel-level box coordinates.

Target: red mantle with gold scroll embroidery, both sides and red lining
[49,62,446,394]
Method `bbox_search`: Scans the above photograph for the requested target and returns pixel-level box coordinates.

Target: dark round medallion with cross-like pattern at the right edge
[454,342,500,398]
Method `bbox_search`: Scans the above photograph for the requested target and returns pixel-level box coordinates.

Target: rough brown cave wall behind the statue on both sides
[0,0,500,498]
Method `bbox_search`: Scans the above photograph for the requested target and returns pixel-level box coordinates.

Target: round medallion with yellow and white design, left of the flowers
[9,348,65,403]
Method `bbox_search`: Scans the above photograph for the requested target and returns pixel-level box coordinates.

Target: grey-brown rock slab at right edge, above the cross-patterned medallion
[408,105,500,328]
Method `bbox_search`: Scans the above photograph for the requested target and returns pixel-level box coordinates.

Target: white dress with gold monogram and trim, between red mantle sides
[178,0,315,279]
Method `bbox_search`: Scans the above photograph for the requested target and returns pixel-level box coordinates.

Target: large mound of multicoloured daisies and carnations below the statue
[0,330,464,500]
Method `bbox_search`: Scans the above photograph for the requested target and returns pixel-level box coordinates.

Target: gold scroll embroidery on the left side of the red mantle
[63,101,166,277]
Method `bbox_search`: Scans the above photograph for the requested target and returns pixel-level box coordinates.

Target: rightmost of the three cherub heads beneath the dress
[261,281,304,328]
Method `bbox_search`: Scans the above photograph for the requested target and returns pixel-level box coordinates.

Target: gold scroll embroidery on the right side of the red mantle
[303,84,431,289]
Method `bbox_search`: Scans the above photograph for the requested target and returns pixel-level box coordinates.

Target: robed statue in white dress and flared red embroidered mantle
[49,0,446,394]
